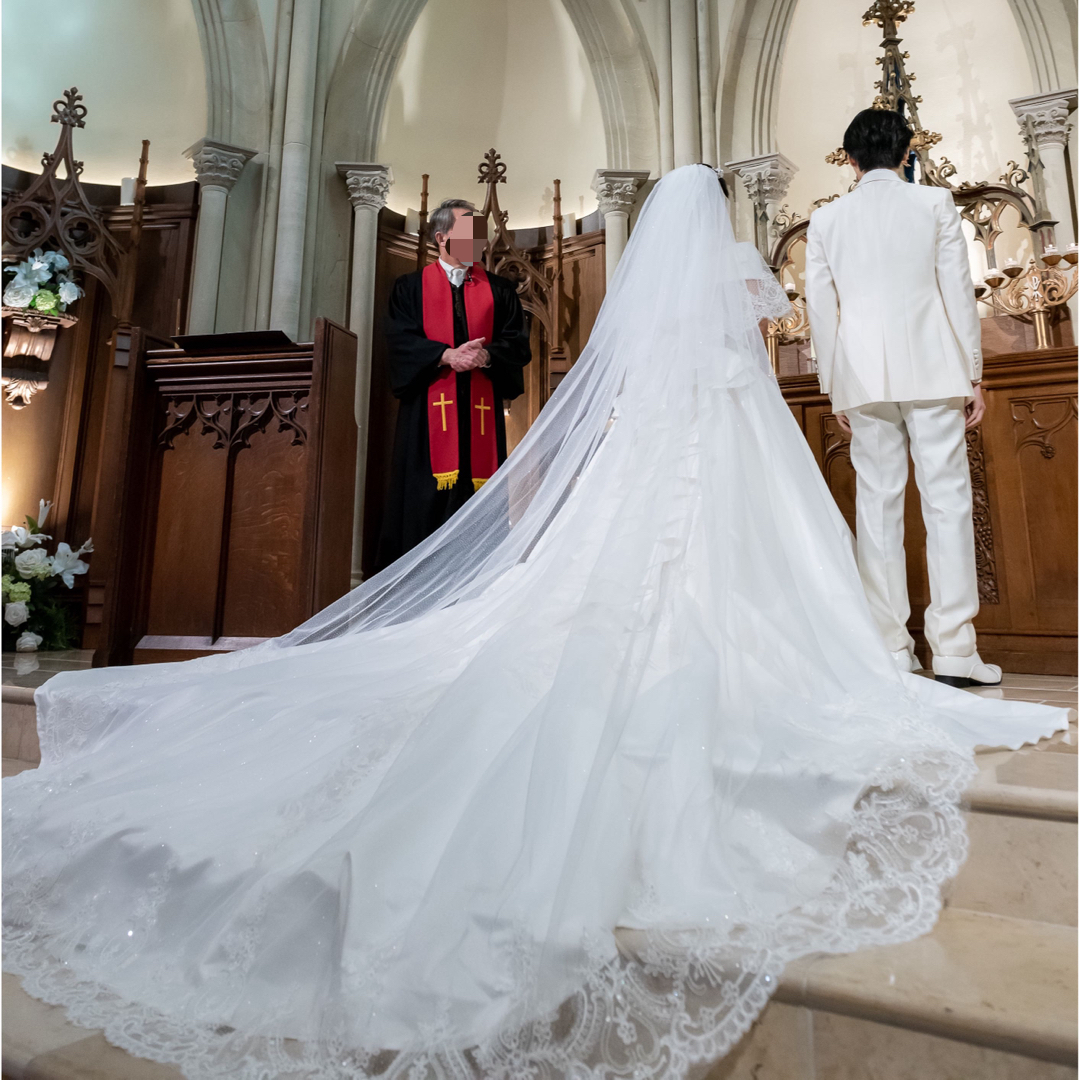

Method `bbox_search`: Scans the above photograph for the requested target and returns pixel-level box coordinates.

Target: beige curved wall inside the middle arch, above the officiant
[377,0,606,228]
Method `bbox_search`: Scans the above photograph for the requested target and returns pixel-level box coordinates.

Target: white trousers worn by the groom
[846,397,978,657]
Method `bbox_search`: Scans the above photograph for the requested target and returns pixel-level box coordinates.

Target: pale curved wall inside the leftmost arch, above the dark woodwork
[2,0,206,184]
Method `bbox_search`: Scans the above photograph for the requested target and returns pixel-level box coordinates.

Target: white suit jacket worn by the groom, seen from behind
[806,168,983,411]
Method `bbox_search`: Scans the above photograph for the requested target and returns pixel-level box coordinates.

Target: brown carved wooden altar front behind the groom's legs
[781,348,1078,674]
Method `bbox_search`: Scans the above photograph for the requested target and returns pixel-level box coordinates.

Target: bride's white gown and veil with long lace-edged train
[3,166,1067,1080]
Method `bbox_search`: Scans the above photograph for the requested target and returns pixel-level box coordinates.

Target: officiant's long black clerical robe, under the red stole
[378,271,531,569]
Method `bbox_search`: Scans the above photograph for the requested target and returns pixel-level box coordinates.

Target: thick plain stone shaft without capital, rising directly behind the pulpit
[270,0,321,341]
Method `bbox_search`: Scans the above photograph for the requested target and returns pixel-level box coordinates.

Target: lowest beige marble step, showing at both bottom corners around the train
[3,910,1077,1080]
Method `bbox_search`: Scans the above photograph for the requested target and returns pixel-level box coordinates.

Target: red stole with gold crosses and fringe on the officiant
[421,262,499,491]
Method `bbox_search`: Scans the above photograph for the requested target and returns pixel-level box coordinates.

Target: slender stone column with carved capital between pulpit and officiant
[337,161,394,586]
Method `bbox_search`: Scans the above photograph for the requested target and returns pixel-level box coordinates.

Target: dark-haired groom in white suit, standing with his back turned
[806,109,1001,687]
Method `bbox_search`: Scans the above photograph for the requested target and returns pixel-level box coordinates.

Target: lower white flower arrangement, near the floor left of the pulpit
[0,499,94,652]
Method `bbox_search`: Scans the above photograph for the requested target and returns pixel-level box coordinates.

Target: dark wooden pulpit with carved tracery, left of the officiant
[86,319,356,664]
